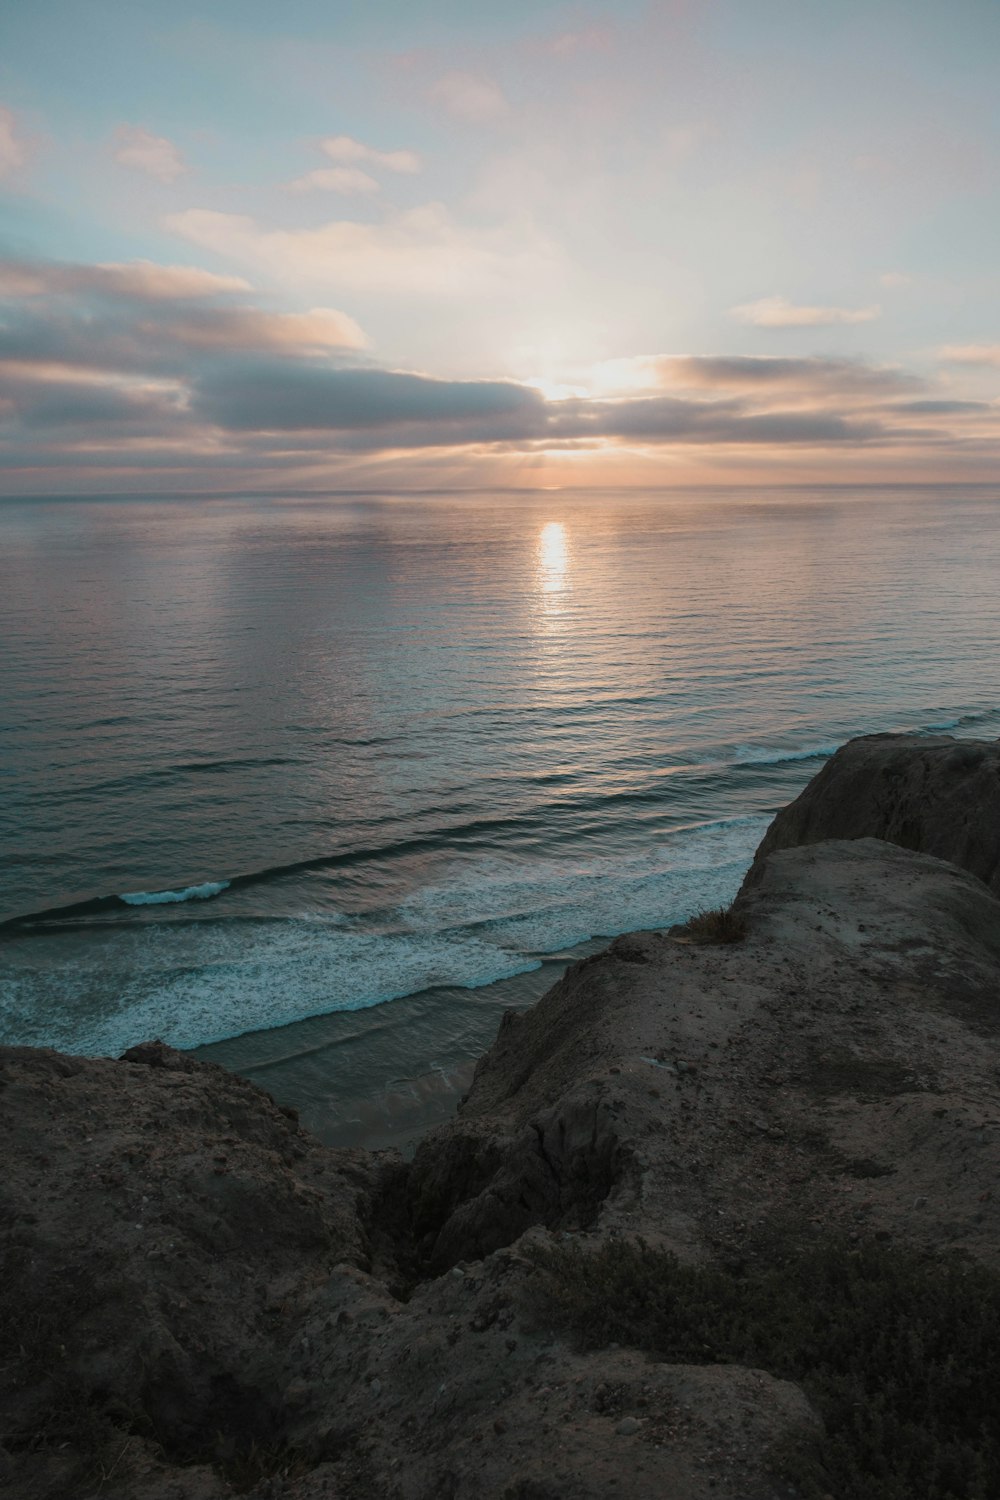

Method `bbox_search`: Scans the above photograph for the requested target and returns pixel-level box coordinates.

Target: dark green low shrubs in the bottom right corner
[537,1241,1000,1500]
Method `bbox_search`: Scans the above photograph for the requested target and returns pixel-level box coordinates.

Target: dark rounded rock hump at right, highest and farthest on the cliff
[747,735,1000,894]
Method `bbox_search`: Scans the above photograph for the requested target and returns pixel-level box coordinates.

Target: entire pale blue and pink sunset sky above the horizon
[0,0,1000,495]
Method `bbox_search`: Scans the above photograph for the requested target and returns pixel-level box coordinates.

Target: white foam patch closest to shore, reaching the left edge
[0,918,538,1056]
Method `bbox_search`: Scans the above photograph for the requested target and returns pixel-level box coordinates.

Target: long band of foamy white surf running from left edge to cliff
[0,816,768,1055]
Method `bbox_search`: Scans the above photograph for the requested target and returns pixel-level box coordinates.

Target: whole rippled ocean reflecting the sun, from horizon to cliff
[0,486,1000,1143]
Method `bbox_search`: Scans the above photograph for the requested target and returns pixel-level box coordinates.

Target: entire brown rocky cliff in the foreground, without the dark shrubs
[0,740,1000,1500]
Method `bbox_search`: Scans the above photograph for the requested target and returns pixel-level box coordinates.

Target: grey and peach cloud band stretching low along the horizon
[0,260,1000,488]
